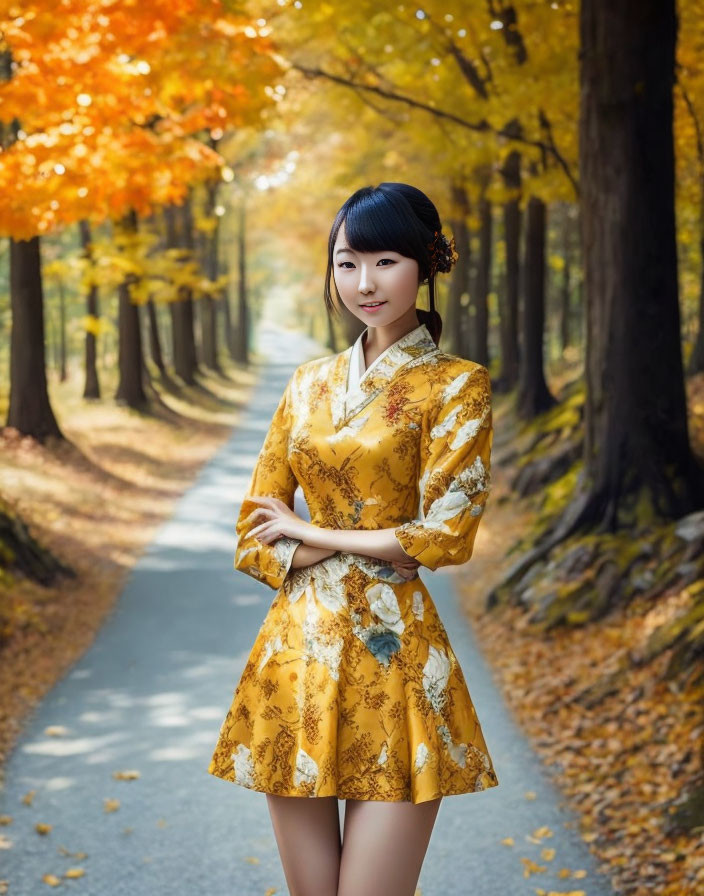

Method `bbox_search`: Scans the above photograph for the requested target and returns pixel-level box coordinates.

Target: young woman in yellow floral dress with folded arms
[208,183,499,896]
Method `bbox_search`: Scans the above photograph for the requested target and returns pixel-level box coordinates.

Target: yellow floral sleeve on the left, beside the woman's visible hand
[235,377,301,589]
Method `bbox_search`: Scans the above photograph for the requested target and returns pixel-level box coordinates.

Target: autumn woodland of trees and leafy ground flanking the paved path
[0,0,704,896]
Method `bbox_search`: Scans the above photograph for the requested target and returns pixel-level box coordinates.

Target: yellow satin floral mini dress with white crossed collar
[208,324,499,803]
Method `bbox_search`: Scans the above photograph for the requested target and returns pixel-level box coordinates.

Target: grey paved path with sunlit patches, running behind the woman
[0,327,612,896]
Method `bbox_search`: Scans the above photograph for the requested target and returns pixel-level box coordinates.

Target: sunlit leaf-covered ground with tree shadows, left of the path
[0,356,256,772]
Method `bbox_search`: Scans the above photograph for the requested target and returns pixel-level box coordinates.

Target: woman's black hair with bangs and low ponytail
[324,183,452,345]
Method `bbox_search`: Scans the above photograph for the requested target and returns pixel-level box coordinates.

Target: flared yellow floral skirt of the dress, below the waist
[208,553,499,803]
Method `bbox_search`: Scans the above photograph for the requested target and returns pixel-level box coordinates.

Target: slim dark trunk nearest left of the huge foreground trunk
[516,196,555,419]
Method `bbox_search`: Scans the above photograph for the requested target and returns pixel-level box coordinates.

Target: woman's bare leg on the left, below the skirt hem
[266,793,342,896]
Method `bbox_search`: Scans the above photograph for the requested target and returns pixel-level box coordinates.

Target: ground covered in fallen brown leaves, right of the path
[456,368,704,896]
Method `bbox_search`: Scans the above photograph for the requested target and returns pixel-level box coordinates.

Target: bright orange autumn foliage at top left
[0,0,279,239]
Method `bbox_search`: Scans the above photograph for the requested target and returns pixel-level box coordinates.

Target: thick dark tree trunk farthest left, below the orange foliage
[7,236,64,442]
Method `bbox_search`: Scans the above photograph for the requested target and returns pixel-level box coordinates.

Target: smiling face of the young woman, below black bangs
[333,221,420,327]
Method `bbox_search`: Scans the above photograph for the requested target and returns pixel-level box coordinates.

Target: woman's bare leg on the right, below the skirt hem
[337,797,442,896]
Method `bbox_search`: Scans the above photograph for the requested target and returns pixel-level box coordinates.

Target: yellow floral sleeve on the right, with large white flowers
[395,364,493,569]
